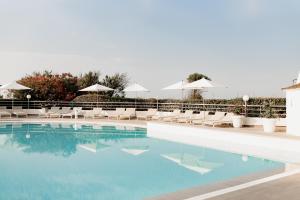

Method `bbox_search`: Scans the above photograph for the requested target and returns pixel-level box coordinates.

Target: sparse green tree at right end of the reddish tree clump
[101,73,128,97]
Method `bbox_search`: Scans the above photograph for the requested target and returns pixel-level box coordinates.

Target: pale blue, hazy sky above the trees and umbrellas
[0,0,300,98]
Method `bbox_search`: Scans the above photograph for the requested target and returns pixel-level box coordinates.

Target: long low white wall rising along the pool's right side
[147,122,300,163]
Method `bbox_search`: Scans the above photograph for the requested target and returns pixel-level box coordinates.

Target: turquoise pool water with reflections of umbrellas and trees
[0,123,283,200]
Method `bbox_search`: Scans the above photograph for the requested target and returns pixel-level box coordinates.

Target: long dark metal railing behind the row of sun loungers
[0,100,286,118]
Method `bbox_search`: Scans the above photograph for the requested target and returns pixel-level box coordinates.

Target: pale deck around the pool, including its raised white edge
[0,118,300,200]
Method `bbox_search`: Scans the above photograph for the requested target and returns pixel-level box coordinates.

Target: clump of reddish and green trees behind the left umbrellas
[14,71,128,101]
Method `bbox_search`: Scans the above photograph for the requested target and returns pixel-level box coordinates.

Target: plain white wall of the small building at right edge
[286,89,300,136]
